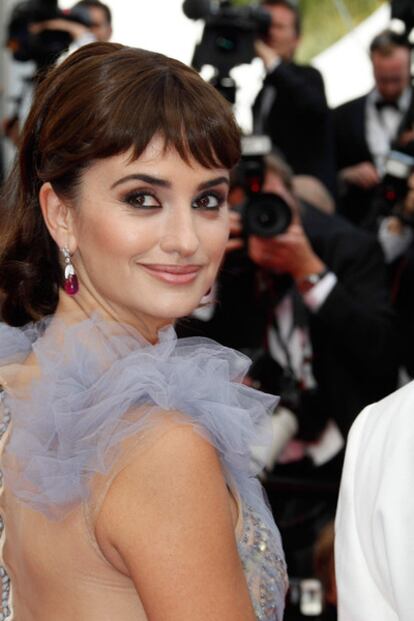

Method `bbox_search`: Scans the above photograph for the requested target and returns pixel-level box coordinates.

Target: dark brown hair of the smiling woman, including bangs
[0,43,240,326]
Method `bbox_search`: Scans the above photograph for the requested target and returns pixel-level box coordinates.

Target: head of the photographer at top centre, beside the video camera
[262,0,301,61]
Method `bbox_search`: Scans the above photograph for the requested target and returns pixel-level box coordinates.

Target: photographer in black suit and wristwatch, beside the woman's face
[179,156,398,452]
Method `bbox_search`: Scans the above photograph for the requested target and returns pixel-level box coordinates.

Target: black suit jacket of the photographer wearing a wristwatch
[179,205,398,435]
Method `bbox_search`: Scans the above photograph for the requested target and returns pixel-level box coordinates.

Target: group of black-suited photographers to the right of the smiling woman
[182,0,414,619]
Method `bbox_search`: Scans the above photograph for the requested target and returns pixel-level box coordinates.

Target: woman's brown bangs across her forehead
[98,60,240,169]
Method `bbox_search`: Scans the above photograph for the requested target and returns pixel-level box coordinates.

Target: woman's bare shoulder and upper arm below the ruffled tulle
[96,412,254,621]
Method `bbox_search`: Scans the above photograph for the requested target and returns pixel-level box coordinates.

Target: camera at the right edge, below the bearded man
[377,150,414,226]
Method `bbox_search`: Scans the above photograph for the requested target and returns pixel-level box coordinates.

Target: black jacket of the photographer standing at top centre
[253,62,335,192]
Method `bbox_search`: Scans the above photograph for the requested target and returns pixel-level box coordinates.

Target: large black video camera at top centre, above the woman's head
[182,0,271,103]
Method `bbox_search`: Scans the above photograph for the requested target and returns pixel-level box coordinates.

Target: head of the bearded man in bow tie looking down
[370,30,411,101]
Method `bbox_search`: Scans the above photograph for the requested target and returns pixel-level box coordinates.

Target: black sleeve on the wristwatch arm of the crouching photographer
[308,206,399,377]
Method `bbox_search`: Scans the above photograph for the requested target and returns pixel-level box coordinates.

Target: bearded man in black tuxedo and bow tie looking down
[333,30,414,228]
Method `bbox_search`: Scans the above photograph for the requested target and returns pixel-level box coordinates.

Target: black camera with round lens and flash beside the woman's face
[232,135,292,237]
